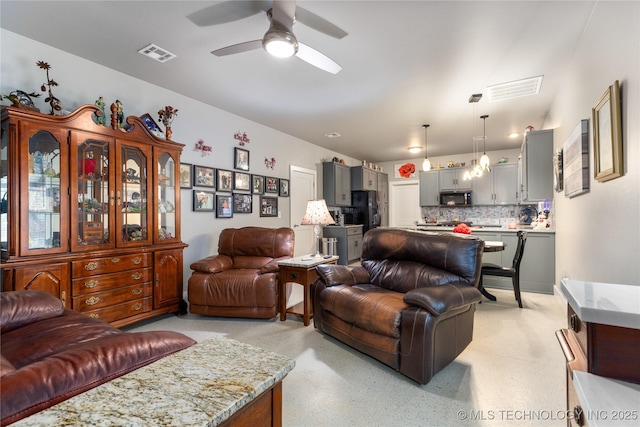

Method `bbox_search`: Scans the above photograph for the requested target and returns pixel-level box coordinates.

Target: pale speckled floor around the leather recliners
[127,289,566,426]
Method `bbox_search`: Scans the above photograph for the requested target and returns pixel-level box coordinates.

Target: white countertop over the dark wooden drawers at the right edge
[560,279,640,329]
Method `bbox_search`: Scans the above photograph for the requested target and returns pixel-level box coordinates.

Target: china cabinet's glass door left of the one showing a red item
[16,125,69,255]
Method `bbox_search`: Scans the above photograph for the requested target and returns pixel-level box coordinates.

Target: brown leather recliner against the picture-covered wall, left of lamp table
[188,227,295,319]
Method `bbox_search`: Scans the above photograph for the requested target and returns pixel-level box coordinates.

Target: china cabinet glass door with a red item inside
[71,133,115,250]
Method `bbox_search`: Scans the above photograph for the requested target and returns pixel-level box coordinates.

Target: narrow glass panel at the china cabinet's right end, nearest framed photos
[155,152,180,243]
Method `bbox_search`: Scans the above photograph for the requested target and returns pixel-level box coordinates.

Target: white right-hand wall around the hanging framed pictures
[544,1,640,285]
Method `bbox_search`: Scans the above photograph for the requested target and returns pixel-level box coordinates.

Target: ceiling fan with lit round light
[188,0,347,74]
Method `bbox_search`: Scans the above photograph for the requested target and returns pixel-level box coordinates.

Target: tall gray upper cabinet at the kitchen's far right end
[520,130,553,202]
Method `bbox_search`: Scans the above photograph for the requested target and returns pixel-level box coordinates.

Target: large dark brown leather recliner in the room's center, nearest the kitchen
[312,228,484,384]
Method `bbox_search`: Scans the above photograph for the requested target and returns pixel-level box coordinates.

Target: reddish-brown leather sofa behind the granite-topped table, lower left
[0,290,195,426]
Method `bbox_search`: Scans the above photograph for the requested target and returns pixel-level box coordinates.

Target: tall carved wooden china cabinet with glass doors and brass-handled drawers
[0,105,187,327]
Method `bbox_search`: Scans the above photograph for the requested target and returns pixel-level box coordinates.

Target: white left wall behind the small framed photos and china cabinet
[0,29,358,292]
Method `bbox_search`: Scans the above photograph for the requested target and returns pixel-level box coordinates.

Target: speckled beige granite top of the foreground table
[13,337,295,427]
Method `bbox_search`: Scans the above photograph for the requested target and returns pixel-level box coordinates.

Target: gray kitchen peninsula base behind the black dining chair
[473,231,556,294]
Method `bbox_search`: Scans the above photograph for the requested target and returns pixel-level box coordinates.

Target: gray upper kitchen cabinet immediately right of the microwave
[472,163,518,205]
